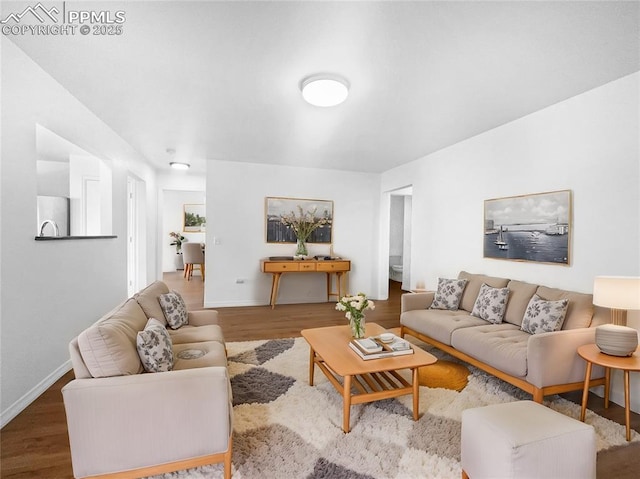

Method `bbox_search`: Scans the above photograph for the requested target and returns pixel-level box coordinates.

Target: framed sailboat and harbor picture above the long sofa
[484,190,573,265]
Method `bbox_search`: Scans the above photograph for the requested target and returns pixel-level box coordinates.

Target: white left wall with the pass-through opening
[0,37,156,425]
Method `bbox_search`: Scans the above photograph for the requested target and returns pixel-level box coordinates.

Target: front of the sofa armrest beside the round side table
[527,328,604,387]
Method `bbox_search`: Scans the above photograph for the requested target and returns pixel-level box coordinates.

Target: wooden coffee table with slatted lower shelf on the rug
[301,323,437,432]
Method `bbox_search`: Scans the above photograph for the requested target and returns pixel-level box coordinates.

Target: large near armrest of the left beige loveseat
[62,367,232,477]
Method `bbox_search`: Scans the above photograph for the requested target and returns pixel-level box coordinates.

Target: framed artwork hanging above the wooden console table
[265,197,333,243]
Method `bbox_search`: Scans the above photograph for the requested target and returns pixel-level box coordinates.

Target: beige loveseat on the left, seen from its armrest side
[62,281,232,478]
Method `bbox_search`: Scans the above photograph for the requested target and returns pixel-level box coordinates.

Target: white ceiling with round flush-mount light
[2,1,640,172]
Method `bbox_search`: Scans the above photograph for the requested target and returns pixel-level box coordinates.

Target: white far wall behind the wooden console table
[204,161,380,307]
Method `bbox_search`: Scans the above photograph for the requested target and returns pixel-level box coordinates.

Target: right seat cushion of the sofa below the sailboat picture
[451,321,530,377]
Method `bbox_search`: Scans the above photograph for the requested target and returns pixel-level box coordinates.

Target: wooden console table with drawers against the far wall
[260,258,351,309]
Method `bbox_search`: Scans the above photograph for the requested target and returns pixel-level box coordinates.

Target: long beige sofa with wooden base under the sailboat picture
[400,271,608,403]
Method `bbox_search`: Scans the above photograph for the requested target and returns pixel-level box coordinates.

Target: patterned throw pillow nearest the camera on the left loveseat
[136,318,173,373]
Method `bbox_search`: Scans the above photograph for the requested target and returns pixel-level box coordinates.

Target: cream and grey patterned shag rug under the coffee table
[155,338,640,479]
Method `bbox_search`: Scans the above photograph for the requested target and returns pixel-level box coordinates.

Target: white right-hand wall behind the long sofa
[381,73,640,411]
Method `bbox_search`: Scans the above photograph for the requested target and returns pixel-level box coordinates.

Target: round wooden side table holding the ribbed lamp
[578,344,640,441]
